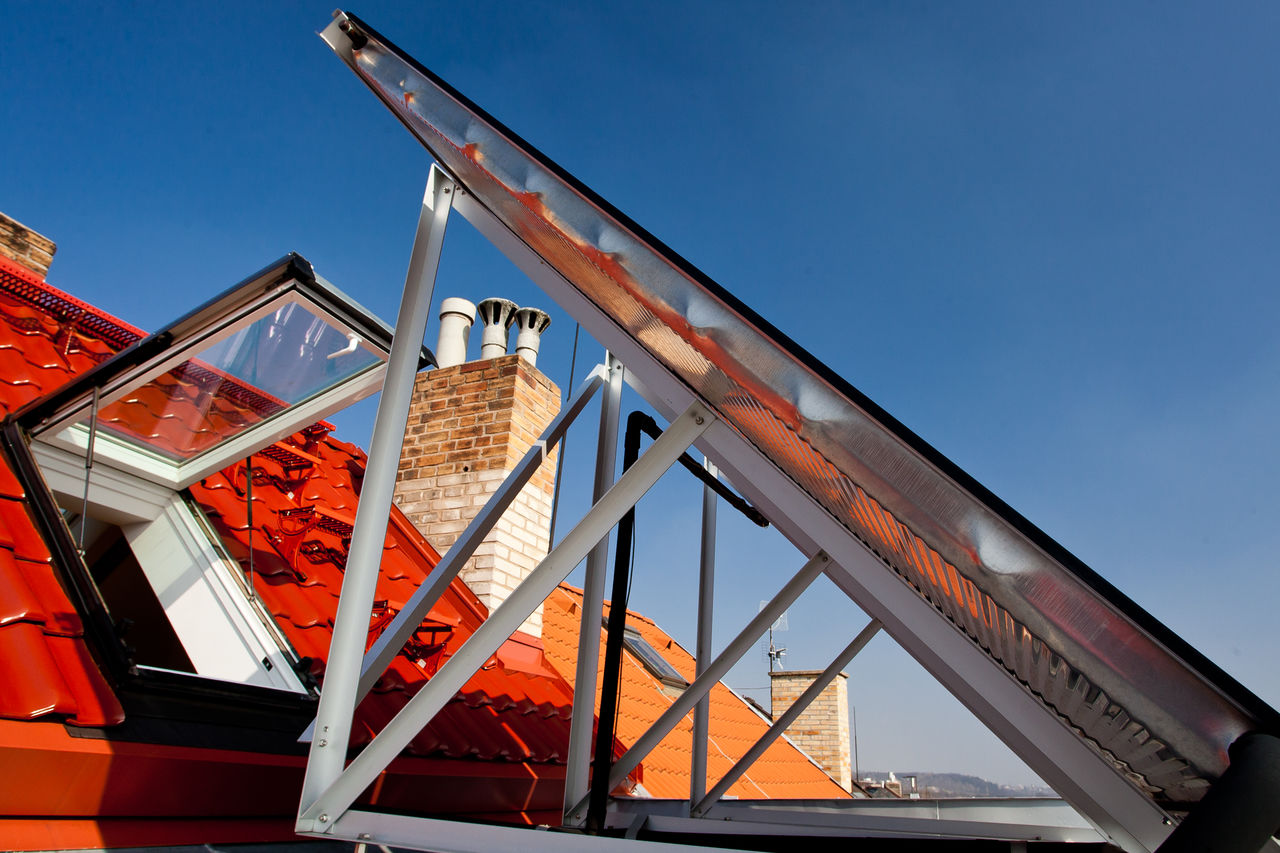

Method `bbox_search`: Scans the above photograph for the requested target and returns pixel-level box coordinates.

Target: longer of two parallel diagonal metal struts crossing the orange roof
[565,550,831,811]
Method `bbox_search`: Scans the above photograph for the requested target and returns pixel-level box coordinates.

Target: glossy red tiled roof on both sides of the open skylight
[0,252,572,763]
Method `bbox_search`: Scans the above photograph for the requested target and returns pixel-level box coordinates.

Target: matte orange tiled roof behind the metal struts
[543,584,849,799]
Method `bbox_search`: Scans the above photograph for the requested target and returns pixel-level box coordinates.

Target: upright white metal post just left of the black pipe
[564,353,623,825]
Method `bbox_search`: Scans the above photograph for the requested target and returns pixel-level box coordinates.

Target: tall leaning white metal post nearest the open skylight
[298,165,454,816]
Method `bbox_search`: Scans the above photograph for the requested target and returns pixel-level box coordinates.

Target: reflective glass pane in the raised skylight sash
[81,301,381,461]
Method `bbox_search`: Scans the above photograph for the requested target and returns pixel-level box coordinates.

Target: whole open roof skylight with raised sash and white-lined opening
[13,255,419,693]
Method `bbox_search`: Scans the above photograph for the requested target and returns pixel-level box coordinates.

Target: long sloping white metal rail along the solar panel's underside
[308,13,1280,850]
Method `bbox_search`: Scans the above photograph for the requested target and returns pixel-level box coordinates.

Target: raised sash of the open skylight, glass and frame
[19,255,409,489]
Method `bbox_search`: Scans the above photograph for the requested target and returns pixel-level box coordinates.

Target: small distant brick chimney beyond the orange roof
[769,670,852,790]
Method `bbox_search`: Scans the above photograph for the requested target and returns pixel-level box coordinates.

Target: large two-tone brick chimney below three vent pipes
[396,302,561,637]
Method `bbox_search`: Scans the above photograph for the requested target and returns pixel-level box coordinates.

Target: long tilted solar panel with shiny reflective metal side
[322,14,1275,803]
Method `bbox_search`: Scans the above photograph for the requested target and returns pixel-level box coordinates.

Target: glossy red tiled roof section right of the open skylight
[192,438,572,763]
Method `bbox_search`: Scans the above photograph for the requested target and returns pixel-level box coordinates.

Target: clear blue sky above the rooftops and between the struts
[0,3,1280,781]
